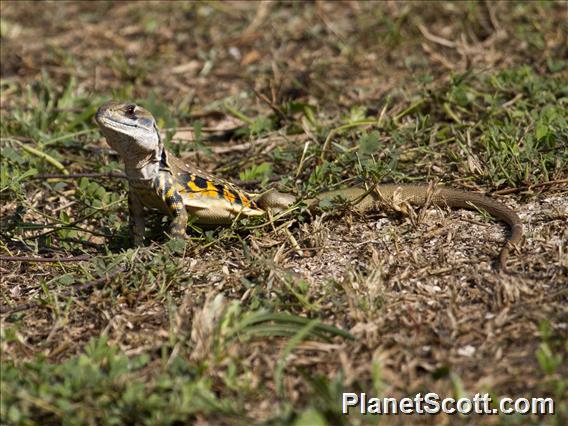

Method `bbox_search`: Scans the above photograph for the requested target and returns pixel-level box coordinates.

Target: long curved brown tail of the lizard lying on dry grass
[307,184,523,271]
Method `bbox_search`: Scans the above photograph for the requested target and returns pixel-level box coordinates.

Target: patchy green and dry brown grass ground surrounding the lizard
[0,2,568,425]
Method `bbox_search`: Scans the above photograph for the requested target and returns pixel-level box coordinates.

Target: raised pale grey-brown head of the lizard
[95,101,161,161]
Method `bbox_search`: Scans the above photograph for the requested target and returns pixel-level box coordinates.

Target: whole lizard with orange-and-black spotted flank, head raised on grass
[95,101,523,271]
